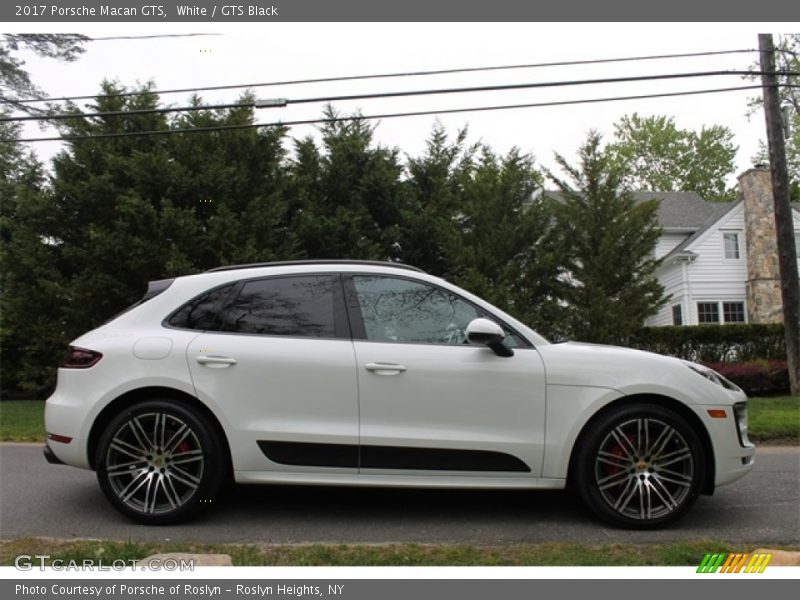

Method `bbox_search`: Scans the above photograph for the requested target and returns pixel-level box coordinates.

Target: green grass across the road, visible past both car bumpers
[0,396,800,445]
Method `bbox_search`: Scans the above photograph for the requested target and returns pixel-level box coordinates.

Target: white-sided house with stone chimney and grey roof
[636,168,800,326]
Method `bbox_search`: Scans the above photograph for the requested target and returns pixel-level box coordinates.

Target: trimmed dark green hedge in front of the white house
[629,323,786,363]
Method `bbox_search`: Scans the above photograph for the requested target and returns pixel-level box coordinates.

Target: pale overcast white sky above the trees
[7,23,798,188]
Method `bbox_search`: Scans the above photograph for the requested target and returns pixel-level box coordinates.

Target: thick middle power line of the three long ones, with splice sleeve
[0,71,784,122]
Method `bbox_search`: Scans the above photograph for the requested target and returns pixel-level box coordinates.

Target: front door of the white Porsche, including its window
[346,275,545,477]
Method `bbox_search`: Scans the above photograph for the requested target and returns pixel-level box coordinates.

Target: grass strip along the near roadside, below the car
[0,538,798,566]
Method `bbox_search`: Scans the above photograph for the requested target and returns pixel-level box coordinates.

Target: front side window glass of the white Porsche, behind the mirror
[353,275,490,344]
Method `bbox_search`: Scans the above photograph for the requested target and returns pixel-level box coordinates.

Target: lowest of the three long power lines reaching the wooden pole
[3,85,772,142]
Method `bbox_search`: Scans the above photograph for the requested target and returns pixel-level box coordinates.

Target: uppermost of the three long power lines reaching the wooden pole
[7,48,758,103]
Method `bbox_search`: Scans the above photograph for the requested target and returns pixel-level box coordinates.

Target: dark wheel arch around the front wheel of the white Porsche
[567,394,716,495]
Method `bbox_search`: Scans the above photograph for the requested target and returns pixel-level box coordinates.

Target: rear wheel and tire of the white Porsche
[95,399,228,525]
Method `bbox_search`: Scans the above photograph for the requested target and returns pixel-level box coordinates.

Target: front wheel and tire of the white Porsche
[573,404,706,529]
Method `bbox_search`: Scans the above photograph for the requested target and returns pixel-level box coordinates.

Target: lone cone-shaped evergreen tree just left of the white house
[550,132,665,343]
